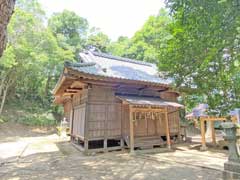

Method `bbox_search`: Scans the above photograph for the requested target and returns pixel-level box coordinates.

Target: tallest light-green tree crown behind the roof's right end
[129,9,171,64]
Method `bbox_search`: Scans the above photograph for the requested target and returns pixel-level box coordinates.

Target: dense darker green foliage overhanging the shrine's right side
[163,0,240,113]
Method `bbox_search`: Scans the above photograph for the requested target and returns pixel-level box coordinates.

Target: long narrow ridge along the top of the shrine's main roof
[87,51,156,67]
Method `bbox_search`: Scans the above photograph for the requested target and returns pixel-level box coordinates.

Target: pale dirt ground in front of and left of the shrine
[0,121,226,180]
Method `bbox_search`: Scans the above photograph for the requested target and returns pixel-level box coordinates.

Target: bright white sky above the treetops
[39,0,164,40]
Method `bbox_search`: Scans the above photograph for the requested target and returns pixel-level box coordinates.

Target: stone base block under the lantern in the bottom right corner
[223,161,240,180]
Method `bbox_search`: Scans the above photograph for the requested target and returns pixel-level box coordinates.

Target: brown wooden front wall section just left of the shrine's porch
[87,86,121,139]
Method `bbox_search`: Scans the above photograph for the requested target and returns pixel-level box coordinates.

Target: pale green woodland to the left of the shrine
[0,1,74,121]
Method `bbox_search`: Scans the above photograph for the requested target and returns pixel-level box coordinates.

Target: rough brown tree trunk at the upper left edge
[0,0,15,57]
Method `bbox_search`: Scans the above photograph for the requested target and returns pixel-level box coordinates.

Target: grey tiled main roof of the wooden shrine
[65,51,172,85]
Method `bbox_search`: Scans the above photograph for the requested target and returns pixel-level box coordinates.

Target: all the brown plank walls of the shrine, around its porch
[70,85,179,140]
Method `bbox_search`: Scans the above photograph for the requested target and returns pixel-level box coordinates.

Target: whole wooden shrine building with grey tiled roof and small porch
[53,51,183,152]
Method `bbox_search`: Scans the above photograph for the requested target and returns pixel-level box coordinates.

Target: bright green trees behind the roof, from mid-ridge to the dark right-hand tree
[109,9,171,64]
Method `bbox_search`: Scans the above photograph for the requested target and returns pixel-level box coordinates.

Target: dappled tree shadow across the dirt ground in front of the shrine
[0,142,221,180]
